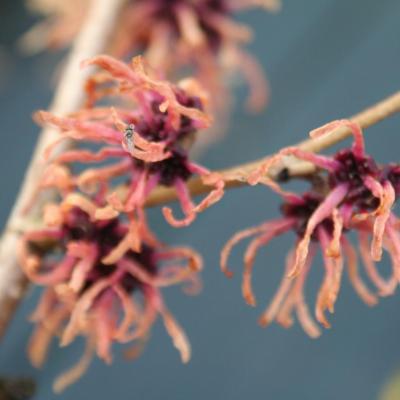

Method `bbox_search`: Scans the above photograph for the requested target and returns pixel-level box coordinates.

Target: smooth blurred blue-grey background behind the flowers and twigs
[0,0,400,400]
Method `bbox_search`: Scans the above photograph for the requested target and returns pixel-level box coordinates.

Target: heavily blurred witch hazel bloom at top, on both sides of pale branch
[20,0,280,111]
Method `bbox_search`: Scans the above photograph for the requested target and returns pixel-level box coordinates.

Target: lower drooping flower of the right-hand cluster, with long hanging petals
[221,192,377,338]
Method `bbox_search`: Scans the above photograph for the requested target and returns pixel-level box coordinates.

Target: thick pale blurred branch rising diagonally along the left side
[0,0,124,338]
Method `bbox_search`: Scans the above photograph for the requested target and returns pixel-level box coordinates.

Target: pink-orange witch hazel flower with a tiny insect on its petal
[36,56,224,227]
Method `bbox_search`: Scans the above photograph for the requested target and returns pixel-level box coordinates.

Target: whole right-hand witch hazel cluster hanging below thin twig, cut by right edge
[221,120,400,337]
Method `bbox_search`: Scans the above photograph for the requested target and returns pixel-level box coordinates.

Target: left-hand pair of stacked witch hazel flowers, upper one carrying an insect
[19,56,228,391]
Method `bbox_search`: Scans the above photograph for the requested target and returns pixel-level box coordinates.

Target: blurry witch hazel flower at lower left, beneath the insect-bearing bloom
[19,194,202,392]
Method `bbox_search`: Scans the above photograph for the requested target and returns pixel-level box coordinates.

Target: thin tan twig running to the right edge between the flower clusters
[146,91,400,207]
